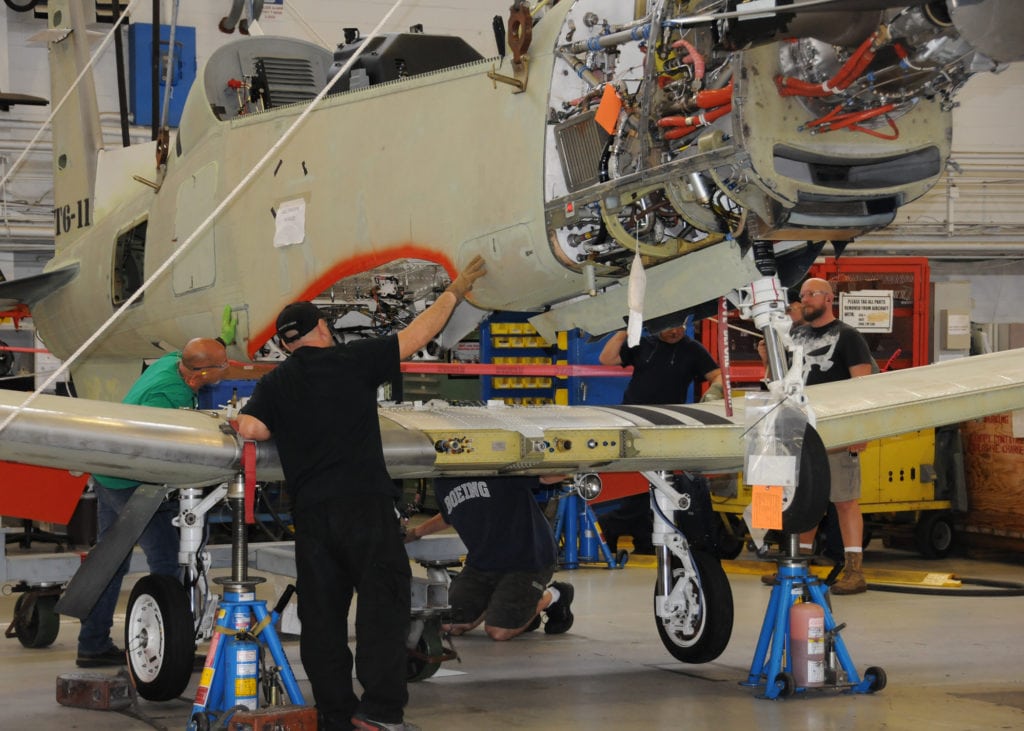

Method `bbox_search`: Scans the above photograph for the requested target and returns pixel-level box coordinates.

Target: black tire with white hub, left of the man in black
[125,573,196,700]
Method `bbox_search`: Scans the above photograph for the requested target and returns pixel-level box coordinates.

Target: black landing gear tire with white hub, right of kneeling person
[654,551,733,663]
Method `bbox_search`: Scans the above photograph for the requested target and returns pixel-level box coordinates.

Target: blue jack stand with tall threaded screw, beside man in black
[185,468,308,731]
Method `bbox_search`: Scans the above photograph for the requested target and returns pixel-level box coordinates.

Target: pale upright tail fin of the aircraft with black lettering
[48,0,102,253]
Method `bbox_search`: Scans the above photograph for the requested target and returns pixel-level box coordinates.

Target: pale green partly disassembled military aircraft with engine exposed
[0,0,1024,696]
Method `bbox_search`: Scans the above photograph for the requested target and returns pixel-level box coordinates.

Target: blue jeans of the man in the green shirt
[78,480,180,654]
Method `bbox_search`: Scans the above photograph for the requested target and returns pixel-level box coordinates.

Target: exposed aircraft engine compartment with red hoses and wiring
[545,0,1019,275]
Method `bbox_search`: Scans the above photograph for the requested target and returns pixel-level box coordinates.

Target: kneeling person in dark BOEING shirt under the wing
[406,476,573,642]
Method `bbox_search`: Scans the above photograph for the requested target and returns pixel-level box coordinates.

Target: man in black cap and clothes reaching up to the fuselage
[239,257,485,731]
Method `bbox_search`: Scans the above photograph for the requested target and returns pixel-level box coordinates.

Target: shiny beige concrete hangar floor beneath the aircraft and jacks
[0,541,1024,731]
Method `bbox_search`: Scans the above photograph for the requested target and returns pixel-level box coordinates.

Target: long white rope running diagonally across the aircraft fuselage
[0,0,404,433]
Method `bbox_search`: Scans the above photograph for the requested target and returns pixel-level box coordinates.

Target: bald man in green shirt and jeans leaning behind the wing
[76,338,227,668]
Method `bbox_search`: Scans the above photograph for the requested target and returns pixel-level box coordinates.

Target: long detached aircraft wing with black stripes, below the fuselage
[0,349,1024,495]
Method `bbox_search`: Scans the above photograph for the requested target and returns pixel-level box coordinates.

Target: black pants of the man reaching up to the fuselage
[294,493,412,729]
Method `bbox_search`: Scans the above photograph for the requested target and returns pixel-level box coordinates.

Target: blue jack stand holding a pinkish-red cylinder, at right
[740,534,886,700]
